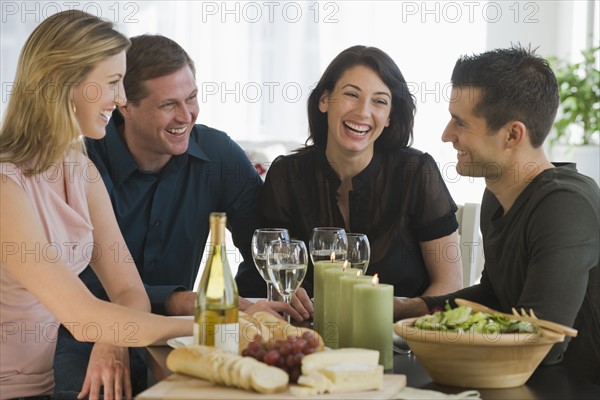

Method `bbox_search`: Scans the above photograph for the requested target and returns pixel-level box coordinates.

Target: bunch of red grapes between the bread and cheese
[242,332,319,383]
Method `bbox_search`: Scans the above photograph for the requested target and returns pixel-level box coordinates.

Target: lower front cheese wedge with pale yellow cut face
[320,363,383,393]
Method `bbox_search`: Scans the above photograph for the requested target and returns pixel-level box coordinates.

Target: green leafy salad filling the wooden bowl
[415,303,539,333]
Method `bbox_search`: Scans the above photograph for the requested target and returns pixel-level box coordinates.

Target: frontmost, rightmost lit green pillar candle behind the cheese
[352,276,394,370]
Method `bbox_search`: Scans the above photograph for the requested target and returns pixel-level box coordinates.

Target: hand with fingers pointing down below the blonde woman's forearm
[77,343,132,400]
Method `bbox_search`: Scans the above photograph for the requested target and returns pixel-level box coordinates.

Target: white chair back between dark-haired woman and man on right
[456,203,483,287]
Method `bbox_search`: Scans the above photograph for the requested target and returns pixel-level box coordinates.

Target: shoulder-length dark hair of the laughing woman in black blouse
[306,46,416,152]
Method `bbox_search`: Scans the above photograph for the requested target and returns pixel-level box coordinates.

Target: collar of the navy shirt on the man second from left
[104,110,210,185]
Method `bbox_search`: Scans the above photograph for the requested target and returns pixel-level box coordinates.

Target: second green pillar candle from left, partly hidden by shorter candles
[323,268,361,349]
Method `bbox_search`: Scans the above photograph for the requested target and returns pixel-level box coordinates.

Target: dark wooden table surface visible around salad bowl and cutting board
[138,347,600,400]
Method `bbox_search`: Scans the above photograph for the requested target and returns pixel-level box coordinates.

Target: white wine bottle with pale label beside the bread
[194,212,240,354]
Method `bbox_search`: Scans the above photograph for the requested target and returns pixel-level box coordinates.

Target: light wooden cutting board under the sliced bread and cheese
[137,374,406,400]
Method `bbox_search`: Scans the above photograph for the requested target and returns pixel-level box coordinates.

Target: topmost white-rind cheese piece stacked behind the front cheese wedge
[302,348,379,375]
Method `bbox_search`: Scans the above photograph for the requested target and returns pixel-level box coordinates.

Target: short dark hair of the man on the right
[452,45,559,147]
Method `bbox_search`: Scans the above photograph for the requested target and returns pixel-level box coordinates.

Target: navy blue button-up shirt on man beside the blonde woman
[81,111,265,314]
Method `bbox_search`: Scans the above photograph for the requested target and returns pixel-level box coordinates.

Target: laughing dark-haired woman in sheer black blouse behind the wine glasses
[261,46,462,298]
